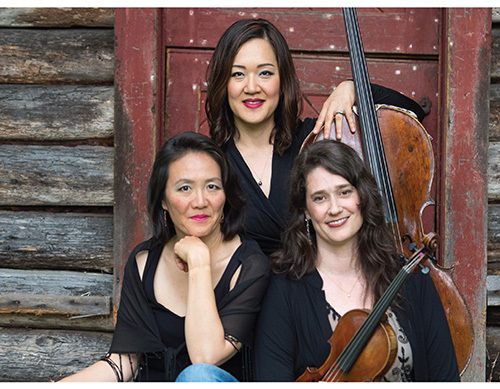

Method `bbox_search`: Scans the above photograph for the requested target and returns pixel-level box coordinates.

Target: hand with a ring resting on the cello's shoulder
[313,81,356,140]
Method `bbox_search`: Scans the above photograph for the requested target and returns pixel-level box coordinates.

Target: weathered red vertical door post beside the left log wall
[114,8,158,304]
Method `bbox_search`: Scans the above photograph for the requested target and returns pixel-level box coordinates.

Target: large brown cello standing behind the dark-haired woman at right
[302,8,474,375]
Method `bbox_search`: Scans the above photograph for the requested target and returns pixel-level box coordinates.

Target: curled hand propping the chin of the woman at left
[174,236,210,272]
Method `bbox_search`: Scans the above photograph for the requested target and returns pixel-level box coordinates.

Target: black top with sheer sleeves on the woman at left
[109,237,271,381]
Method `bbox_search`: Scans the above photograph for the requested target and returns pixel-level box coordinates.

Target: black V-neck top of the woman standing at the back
[224,84,424,255]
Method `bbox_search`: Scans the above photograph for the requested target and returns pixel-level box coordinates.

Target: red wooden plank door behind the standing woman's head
[163,8,440,139]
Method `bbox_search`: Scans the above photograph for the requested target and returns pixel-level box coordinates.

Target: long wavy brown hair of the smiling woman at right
[271,140,401,301]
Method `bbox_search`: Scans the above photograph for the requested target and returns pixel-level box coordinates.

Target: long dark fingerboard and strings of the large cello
[342,8,398,223]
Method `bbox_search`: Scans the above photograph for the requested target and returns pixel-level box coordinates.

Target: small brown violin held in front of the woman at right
[296,232,438,382]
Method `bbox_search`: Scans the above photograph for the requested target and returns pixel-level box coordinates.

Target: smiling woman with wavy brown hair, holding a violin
[255,140,459,381]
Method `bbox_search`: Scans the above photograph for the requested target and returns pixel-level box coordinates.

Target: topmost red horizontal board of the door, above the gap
[164,8,440,56]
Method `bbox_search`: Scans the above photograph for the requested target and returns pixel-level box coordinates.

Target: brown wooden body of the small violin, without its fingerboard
[296,309,397,382]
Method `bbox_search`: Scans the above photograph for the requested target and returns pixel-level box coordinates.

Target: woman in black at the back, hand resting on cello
[206,19,424,255]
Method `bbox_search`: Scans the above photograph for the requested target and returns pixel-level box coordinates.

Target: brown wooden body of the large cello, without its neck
[302,105,474,375]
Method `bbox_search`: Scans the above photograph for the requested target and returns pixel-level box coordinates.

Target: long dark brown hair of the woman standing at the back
[205,19,302,155]
